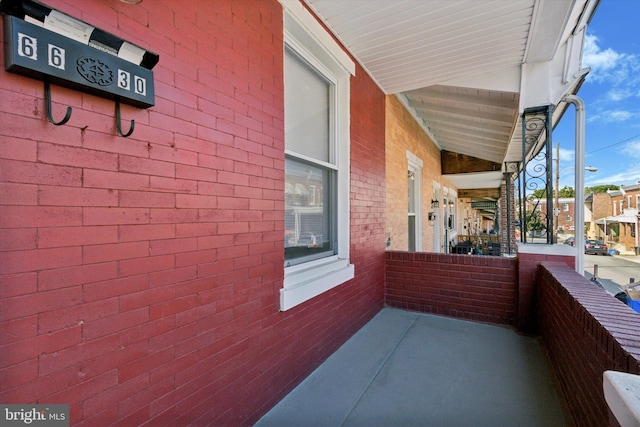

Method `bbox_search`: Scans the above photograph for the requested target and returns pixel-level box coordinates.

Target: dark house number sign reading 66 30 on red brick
[4,16,155,108]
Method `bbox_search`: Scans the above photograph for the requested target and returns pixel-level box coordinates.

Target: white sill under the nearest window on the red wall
[280,257,355,311]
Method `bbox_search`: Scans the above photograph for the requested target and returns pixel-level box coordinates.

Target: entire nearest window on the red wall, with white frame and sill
[280,2,355,310]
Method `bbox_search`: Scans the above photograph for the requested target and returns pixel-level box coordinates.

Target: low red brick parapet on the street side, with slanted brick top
[538,262,640,426]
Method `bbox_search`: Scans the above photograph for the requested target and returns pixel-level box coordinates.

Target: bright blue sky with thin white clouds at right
[553,0,640,188]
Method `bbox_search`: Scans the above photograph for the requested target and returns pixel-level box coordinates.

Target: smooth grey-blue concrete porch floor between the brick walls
[256,308,566,427]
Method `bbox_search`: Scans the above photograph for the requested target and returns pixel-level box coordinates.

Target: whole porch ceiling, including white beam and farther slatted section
[302,0,599,188]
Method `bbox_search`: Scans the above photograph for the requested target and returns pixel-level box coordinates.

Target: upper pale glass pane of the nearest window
[284,49,332,162]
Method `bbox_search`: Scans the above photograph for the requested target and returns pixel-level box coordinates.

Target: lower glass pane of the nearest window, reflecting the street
[284,158,334,264]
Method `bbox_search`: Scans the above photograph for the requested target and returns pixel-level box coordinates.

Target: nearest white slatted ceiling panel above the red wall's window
[307,0,536,94]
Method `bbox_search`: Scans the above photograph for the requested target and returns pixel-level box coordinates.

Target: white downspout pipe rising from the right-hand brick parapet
[562,95,585,275]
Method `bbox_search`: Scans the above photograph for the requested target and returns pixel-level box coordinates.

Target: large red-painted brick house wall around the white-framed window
[0,0,385,425]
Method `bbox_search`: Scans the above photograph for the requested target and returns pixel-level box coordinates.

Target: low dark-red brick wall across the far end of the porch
[385,251,516,325]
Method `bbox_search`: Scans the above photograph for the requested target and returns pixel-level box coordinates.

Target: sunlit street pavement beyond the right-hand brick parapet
[584,255,640,295]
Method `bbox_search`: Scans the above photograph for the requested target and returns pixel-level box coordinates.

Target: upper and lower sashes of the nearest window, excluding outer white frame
[284,47,337,266]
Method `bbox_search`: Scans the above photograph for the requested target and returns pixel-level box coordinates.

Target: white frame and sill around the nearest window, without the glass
[280,0,355,311]
